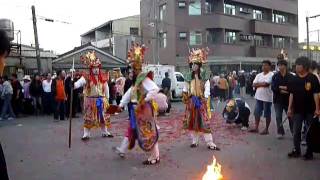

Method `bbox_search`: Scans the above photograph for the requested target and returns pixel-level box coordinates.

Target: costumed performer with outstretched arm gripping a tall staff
[74,51,113,141]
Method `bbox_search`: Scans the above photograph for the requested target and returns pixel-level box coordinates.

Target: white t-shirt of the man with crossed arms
[253,72,273,102]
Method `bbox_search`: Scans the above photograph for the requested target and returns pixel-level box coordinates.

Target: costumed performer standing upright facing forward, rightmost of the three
[183,49,220,150]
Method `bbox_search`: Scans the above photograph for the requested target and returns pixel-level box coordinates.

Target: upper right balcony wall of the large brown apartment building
[251,20,298,38]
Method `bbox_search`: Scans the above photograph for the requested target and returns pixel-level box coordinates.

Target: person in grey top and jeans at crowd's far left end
[0,76,15,120]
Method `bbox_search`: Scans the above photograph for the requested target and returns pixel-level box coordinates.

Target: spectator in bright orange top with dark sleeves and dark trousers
[51,71,67,121]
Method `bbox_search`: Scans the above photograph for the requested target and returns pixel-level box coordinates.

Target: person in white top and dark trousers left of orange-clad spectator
[42,73,53,115]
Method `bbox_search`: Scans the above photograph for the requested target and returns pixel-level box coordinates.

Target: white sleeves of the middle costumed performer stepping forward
[119,77,160,107]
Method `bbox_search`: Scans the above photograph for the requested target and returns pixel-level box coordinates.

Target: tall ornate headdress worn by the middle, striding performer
[128,42,146,73]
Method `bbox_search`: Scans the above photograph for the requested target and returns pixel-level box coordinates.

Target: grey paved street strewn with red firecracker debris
[0,99,320,180]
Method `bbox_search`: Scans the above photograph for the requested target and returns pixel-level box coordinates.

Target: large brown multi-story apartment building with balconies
[140,0,298,71]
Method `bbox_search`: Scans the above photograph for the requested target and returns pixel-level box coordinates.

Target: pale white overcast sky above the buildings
[0,0,320,53]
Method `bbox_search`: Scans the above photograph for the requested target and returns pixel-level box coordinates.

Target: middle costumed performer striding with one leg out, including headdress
[113,44,160,165]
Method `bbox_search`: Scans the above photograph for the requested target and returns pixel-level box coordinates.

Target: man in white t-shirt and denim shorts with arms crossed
[250,60,273,135]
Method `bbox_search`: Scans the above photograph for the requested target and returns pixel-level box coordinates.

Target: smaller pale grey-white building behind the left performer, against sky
[81,15,140,59]
